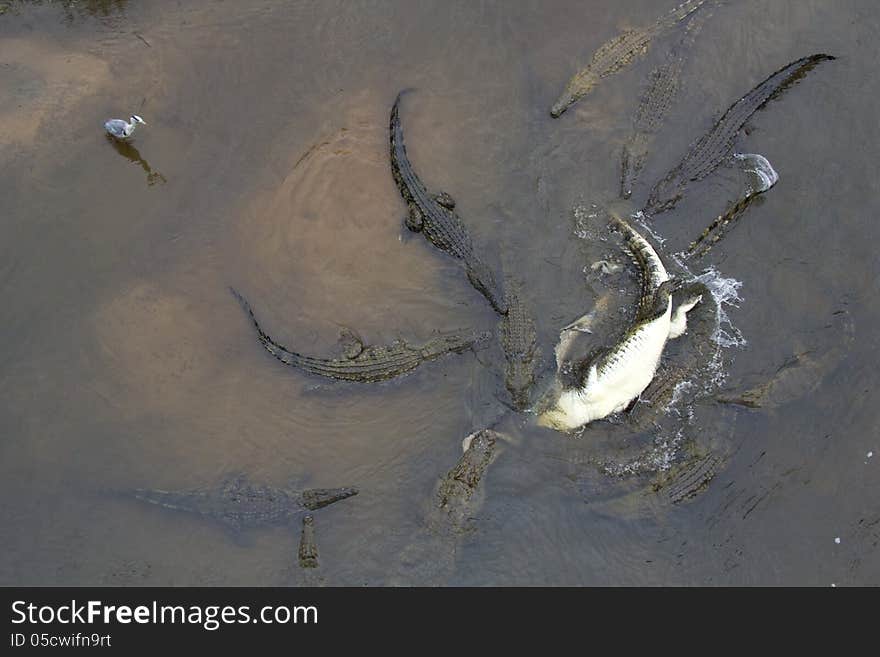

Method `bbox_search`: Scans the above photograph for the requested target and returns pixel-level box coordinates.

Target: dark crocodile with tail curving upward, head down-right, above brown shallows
[390,91,507,315]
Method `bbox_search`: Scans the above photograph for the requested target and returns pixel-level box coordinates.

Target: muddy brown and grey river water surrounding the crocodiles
[0,0,880,586]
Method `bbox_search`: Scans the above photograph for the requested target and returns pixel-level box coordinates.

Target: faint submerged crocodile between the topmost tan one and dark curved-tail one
[620,11,710,199]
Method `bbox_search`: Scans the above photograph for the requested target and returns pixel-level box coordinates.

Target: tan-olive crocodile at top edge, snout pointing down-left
[550,0,706,119]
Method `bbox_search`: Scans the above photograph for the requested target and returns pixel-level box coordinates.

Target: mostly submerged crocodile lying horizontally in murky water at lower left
[131,475,358,530]
